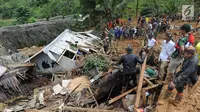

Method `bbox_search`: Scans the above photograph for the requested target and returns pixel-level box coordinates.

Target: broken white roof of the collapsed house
[27,29,100,61]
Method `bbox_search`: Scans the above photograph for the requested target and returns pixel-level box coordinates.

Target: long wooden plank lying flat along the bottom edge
[62,106,127,112]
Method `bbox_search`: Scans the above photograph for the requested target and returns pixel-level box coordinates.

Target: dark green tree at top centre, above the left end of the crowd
[81,0,131,24]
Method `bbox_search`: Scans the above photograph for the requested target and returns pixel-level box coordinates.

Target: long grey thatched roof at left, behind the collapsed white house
[0,18,73,56]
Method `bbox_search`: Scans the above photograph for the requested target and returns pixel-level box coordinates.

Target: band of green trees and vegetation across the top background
[0,0,200,26]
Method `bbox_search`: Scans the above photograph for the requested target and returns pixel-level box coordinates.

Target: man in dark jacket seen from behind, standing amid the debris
[118,45,145,93]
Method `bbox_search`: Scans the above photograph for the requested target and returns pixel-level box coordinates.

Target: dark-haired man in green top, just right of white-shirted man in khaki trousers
[167,24,191,81]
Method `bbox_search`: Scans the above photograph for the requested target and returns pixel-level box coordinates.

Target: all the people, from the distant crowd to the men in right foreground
[103,17,200,104]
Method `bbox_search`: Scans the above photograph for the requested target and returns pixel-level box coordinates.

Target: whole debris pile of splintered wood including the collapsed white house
[0,30,162,112]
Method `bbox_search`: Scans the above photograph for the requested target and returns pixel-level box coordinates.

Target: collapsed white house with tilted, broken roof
[25,29,100,73]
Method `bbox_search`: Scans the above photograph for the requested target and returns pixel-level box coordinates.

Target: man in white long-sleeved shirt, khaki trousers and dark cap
[159,32,175,80]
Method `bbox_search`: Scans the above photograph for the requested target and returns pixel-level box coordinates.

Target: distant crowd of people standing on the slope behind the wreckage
[102,16,171,52]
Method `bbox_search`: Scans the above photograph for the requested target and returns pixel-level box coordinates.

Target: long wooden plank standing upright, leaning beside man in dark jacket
[134,56,147,110]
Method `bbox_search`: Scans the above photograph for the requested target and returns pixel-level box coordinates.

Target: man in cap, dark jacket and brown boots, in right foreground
[165,46,198,104]
